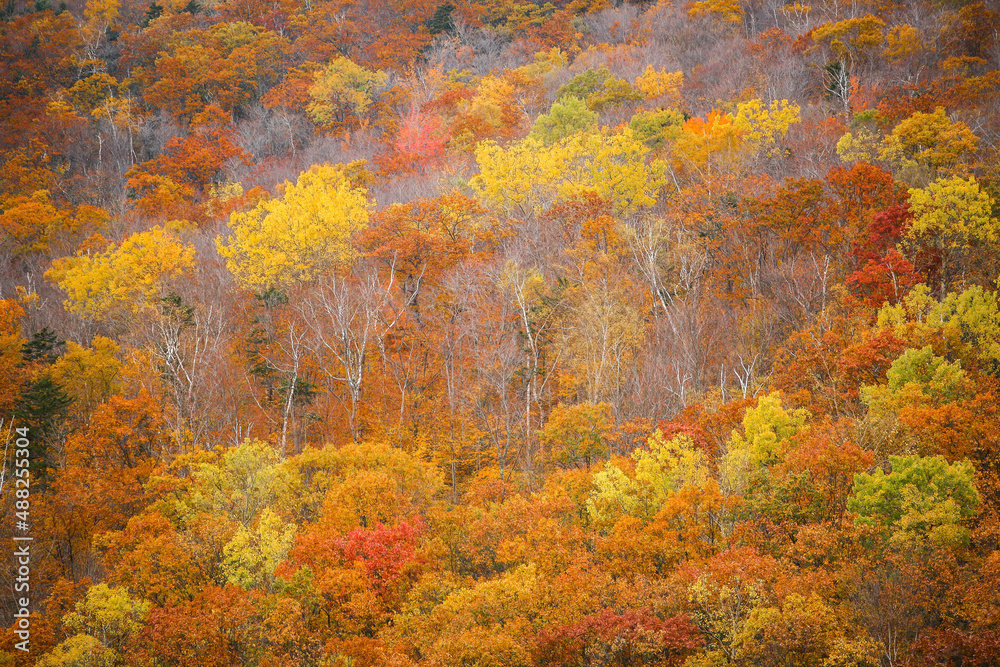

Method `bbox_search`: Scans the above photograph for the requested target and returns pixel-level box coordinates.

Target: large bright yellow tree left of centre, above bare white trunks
[215,164,371,292]
